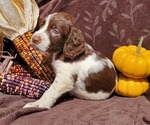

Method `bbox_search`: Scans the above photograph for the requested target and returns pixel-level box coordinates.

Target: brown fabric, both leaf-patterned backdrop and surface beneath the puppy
[0,0,150,125]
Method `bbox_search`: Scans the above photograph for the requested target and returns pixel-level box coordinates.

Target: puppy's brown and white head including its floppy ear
[31,12,85,59]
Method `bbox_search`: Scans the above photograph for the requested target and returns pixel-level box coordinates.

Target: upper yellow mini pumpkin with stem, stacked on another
[112,37,150,78]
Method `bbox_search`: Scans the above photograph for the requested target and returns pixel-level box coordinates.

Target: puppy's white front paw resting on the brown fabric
[23,100,51,109]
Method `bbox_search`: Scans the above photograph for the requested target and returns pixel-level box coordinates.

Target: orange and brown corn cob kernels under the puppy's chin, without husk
[13,32,54,83]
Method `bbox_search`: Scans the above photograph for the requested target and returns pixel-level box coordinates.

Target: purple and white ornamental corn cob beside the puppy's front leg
[0,73,50,98]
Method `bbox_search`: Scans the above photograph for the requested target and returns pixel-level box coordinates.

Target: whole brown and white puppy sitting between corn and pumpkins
[24,12,117,109]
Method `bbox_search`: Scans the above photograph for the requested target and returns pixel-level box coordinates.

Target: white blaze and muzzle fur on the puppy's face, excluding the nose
[31,13,56,51]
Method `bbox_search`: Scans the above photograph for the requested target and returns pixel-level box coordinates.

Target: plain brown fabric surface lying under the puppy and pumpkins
[0,93,150,125]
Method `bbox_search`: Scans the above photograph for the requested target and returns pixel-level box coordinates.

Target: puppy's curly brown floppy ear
[63,27,85,59]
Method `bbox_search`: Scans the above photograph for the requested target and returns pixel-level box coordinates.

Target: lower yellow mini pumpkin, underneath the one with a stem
[115,74,149,97]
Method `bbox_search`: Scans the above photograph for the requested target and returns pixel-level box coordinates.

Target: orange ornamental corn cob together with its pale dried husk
[0,0,54,83]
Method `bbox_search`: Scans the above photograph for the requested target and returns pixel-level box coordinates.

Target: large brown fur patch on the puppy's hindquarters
[85,67,116,92]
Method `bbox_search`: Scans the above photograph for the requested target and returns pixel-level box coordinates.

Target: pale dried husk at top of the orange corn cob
[0,0,39,41]
